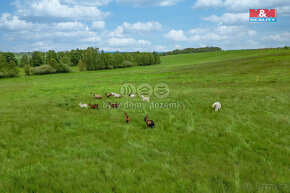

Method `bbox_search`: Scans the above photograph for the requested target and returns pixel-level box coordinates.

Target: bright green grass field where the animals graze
[0,49,290,193]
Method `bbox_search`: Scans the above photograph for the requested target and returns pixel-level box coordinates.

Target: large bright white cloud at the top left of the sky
[16,0,108,20]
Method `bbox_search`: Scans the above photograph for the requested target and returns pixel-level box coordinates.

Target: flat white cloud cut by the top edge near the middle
[116,0,182,7]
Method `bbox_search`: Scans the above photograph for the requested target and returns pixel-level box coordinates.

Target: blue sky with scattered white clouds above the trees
[0,0,290,52]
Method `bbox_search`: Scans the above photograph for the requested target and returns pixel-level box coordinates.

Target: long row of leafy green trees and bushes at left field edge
[0,47,160,78]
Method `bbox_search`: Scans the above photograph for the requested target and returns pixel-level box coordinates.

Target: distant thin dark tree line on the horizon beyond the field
[159,47,222,56]
